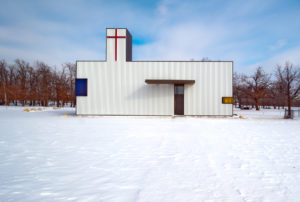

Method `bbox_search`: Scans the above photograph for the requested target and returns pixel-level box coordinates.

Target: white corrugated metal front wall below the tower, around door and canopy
[77,61,233,115]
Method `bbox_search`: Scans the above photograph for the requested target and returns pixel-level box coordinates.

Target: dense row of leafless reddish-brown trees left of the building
[0,59,76,107]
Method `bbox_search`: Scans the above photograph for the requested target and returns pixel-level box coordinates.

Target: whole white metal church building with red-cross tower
[75,28,233,116]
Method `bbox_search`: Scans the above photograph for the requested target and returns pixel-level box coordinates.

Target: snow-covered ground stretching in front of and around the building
[0,107,300,202]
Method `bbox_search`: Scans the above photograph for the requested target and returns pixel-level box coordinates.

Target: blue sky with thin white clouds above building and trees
[0,0,300,72]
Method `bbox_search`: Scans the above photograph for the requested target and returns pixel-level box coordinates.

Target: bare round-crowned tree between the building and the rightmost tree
[244,67,270,110]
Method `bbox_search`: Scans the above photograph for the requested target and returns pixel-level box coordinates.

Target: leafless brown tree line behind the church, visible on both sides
[0,59,300,115]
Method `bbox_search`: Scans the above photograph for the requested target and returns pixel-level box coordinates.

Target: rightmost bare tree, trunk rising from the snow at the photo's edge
[276,62,300,118]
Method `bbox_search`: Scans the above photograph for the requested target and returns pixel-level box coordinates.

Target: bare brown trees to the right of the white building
[233,62,300,117]
